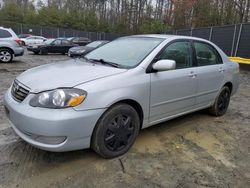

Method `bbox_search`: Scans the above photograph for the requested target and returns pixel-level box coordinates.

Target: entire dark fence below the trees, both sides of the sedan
[0,22,250,58]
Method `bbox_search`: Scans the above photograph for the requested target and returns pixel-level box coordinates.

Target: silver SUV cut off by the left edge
[0,27,24,63]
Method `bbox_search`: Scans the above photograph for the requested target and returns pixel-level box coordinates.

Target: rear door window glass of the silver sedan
[194,42,222,66]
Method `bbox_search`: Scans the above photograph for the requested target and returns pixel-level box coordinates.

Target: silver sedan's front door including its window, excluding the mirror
[149,40,197,123]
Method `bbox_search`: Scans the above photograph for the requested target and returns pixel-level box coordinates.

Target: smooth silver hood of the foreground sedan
[17,59,127,93]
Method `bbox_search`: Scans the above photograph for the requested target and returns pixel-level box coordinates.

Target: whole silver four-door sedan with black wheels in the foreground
[4,35,239,158]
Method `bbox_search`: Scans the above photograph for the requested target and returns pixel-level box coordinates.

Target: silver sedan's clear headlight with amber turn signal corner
[30,88,87,108]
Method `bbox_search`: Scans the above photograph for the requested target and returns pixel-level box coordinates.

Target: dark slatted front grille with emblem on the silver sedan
[11,80,29,102]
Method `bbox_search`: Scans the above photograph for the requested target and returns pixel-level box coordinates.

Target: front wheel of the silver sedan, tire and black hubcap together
[91,103,140,158]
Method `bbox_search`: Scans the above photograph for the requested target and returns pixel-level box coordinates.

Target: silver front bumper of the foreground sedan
[4,89,105,152]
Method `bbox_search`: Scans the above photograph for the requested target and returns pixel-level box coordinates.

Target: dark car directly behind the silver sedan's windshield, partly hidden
[68,40,109,57]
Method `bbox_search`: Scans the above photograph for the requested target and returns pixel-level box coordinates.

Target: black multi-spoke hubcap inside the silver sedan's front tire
[104,114,135,152]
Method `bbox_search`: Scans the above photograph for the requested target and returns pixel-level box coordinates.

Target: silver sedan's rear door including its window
[193,41,225,108]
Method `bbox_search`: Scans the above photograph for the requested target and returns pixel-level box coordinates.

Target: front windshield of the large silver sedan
[85,37,164,68]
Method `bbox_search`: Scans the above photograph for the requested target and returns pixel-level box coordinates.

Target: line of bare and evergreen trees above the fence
[0,0,250,34]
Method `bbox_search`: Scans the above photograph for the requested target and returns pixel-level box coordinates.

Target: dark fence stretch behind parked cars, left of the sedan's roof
[0,22,121,41]
